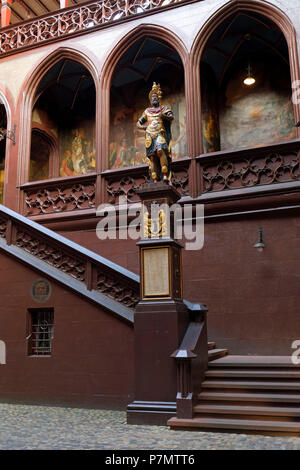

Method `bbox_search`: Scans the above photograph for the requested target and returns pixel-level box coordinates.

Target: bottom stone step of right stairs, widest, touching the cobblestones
[168,417,300,435]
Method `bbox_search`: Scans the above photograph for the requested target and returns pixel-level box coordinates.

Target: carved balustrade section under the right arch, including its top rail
[197,139,300,196]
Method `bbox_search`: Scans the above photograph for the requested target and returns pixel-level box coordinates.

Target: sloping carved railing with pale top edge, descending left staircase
[0,205,139,308]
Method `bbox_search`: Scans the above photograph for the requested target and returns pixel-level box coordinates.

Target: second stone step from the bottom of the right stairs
[194,402,300,417]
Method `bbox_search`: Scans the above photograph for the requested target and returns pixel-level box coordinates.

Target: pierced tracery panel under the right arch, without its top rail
[200,143,300,192]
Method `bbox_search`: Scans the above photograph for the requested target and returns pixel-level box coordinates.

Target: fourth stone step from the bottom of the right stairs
[201,379,300,391]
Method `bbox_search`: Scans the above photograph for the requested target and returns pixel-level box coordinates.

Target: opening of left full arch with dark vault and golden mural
[29,58,96,181]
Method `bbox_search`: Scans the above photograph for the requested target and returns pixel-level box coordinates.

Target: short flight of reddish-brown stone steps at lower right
[168,354,300,436]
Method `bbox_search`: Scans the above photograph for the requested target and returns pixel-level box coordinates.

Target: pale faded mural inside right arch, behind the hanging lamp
[220,59,296,150]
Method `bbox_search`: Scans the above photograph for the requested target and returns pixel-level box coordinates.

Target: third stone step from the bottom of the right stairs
[198,391,300,404]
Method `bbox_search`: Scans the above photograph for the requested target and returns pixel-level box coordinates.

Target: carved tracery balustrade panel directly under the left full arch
[22,176,96,216]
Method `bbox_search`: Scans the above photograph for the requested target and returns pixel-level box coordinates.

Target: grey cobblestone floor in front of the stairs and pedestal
[0,404,300,450]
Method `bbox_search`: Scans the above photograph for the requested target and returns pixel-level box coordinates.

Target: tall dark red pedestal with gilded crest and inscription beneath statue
[127,182,189,424]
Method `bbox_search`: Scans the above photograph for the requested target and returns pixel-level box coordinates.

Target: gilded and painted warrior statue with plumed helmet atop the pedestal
[137,82,174,183]
